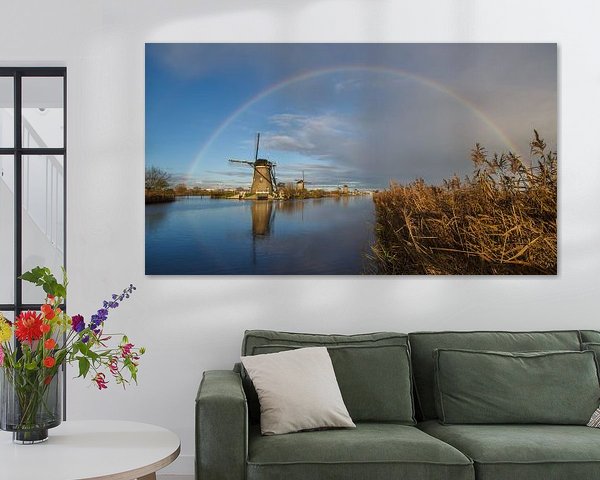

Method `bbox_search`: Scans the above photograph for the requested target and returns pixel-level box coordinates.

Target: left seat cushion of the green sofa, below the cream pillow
[247,423,475,480]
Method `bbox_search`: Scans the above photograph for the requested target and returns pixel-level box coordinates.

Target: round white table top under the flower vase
[0,420,180,480]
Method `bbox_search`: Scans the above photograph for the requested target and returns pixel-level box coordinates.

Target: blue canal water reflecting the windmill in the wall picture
[146,195,374,275]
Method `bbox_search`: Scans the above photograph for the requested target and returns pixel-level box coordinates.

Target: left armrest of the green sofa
[196,370,248,480]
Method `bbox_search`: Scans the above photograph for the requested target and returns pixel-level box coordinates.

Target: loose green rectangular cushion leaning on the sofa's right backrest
[434,349,600,425]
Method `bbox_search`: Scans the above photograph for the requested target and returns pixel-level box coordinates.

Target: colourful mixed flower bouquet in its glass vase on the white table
[0,267,144,443]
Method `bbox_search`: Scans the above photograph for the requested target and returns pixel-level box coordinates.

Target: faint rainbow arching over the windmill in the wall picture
[188,65,521,176]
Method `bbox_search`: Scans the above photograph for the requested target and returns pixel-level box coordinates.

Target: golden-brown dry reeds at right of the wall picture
[372,132,557,275]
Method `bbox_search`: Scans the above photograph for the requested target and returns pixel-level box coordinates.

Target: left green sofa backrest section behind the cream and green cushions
[242,330,408,423]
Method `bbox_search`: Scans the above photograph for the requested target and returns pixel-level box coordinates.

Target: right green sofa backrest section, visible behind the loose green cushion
[409,330,581,420]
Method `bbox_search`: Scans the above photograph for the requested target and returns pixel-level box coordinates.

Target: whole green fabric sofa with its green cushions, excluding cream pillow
[196,330,600,480]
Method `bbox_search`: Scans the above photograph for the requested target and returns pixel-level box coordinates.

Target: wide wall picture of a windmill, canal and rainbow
[145,43,558,275]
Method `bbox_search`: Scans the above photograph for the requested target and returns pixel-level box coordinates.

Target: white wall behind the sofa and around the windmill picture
[0,0,600,473]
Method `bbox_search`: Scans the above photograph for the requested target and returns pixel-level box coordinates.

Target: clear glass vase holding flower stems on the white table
[0,367,62,444]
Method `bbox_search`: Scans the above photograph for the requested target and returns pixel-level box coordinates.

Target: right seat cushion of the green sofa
[419,420,600,480]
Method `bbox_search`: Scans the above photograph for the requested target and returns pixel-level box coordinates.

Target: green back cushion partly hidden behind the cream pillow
[254,345,416,425]
